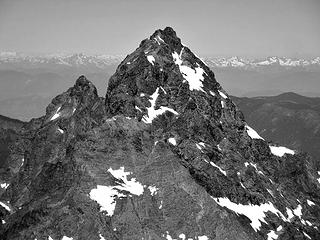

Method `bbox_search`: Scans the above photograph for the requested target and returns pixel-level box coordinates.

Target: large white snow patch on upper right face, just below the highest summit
[172,49,206,92]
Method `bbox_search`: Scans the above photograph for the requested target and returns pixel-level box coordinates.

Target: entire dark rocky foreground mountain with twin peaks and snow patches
[0,27,320,240]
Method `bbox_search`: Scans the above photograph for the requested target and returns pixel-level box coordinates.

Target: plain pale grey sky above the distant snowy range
[0,0,320,57]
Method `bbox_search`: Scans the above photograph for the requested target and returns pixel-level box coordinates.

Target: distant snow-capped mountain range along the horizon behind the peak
[0,52,320,68]
